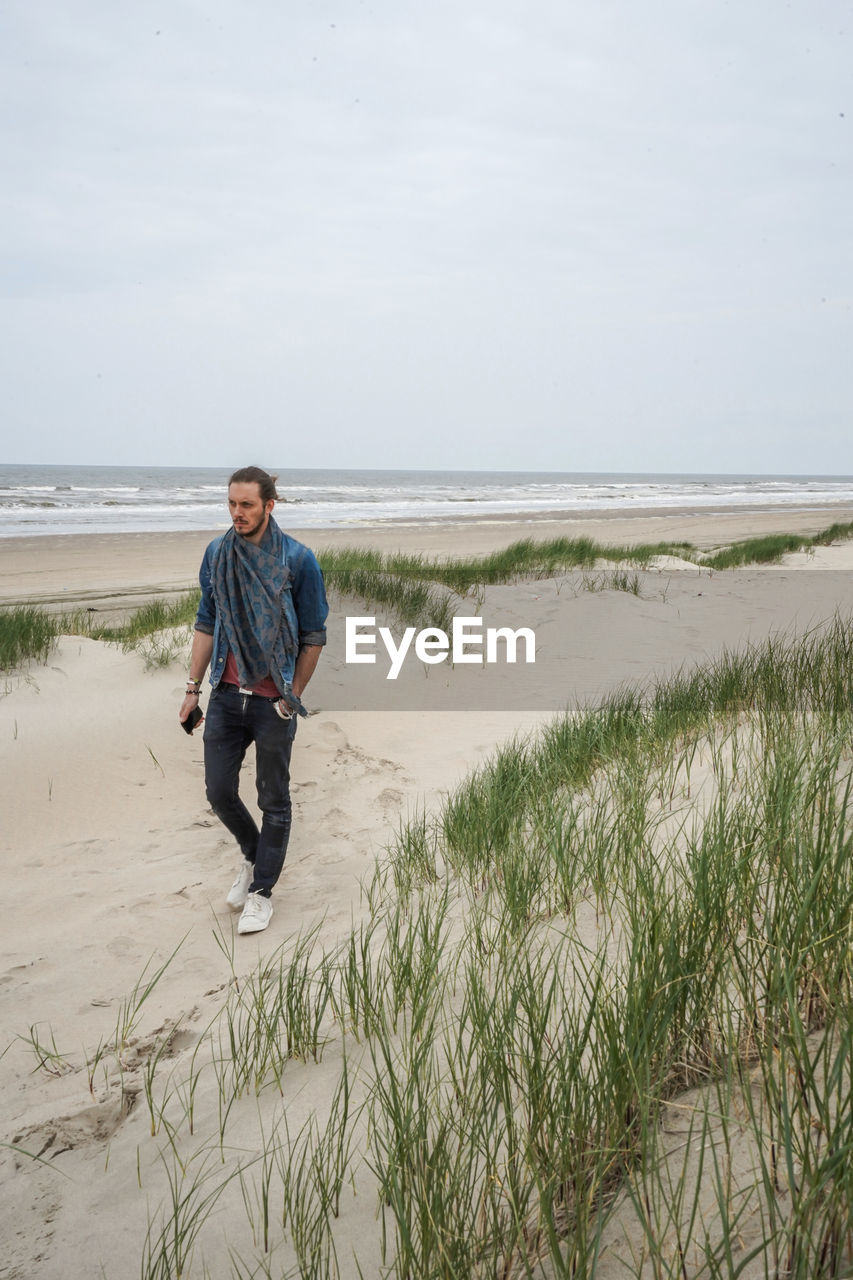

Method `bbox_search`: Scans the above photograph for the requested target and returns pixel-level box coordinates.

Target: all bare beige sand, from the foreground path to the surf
[0,509,853,1280]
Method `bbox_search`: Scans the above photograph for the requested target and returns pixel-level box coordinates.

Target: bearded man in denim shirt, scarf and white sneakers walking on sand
[178,467,329,933]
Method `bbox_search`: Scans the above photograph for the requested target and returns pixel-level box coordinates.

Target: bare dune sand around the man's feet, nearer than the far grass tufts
[0,517,853,1280]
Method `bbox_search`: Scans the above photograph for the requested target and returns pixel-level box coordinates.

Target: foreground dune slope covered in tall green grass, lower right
[11,618,853,1280]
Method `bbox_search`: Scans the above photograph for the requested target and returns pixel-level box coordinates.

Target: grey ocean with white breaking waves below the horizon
[0,466,853,538]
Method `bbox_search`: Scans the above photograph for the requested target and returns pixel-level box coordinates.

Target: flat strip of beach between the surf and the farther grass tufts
[0,504,853,614]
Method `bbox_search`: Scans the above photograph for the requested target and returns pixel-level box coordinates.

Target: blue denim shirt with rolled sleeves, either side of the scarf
[196,530,329,689]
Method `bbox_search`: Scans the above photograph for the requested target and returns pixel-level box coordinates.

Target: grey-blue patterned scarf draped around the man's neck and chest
[211,516,298,692]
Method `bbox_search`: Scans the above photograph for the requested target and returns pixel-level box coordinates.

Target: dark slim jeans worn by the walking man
[204,685,296,897]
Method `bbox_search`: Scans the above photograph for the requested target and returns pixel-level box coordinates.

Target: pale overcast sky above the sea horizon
[0,0,853,474]
